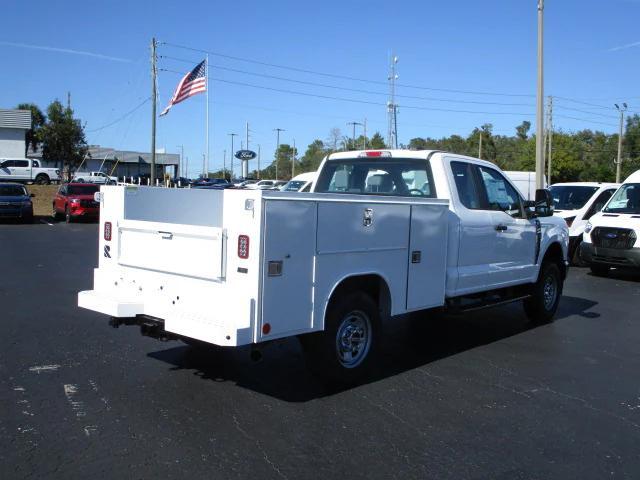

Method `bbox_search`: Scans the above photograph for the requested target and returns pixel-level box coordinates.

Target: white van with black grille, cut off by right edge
[580,170,640,275]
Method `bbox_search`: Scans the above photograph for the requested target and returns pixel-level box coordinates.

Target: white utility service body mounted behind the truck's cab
[78,186,449,346]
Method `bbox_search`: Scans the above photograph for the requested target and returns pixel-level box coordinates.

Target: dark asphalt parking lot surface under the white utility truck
[0,221,640,479]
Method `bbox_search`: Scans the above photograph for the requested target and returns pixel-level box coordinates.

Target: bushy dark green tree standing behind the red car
[42,100,88,178]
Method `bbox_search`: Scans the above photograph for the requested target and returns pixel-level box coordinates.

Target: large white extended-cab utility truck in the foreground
[78,150,568,381]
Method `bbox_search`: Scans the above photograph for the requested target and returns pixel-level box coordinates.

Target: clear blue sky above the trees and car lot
[0,0,640,175]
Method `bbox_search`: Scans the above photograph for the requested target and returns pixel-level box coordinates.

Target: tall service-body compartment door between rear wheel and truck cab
[407,205,449,310]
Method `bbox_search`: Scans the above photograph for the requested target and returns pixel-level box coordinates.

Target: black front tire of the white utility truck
[523,262,562,324]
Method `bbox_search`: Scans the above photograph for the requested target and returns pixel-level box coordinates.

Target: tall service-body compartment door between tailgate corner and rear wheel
[256,199,316,340]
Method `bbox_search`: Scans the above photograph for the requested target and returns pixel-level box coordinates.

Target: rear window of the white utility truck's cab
[315,158,435,198]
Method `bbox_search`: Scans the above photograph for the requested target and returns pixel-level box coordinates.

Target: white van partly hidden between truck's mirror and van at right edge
[549,182,620,265]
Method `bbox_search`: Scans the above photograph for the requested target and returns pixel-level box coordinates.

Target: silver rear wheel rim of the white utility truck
[336,311,371,368]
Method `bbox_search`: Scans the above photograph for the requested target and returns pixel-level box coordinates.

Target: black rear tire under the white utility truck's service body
[300,292,380,383]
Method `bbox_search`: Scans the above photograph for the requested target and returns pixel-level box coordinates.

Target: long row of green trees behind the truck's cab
[229,114,640,183]
